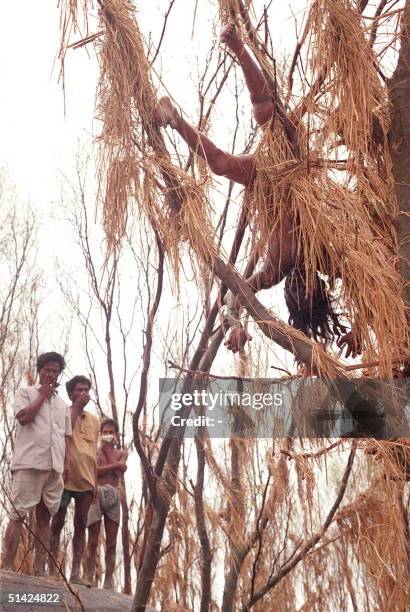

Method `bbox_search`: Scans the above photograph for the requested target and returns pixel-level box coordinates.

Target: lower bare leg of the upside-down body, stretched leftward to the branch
[155,97,254,185]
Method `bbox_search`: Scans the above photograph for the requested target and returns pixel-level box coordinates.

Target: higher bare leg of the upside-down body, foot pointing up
[220,23,275,125]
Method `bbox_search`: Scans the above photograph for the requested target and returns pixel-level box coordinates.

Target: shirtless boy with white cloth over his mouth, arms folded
[87,419,128,589]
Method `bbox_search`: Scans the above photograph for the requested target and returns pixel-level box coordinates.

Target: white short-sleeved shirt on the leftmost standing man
[11,385,71,474]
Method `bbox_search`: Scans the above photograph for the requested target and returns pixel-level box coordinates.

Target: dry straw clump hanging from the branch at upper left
[62,0,216,268]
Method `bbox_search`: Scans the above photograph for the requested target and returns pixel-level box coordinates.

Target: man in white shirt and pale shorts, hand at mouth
[3,352,71,576]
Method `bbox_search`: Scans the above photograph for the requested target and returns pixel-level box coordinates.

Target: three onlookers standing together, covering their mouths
[2,352,127,589]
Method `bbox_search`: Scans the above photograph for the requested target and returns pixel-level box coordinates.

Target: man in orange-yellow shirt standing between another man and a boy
[49,376,99,586]
